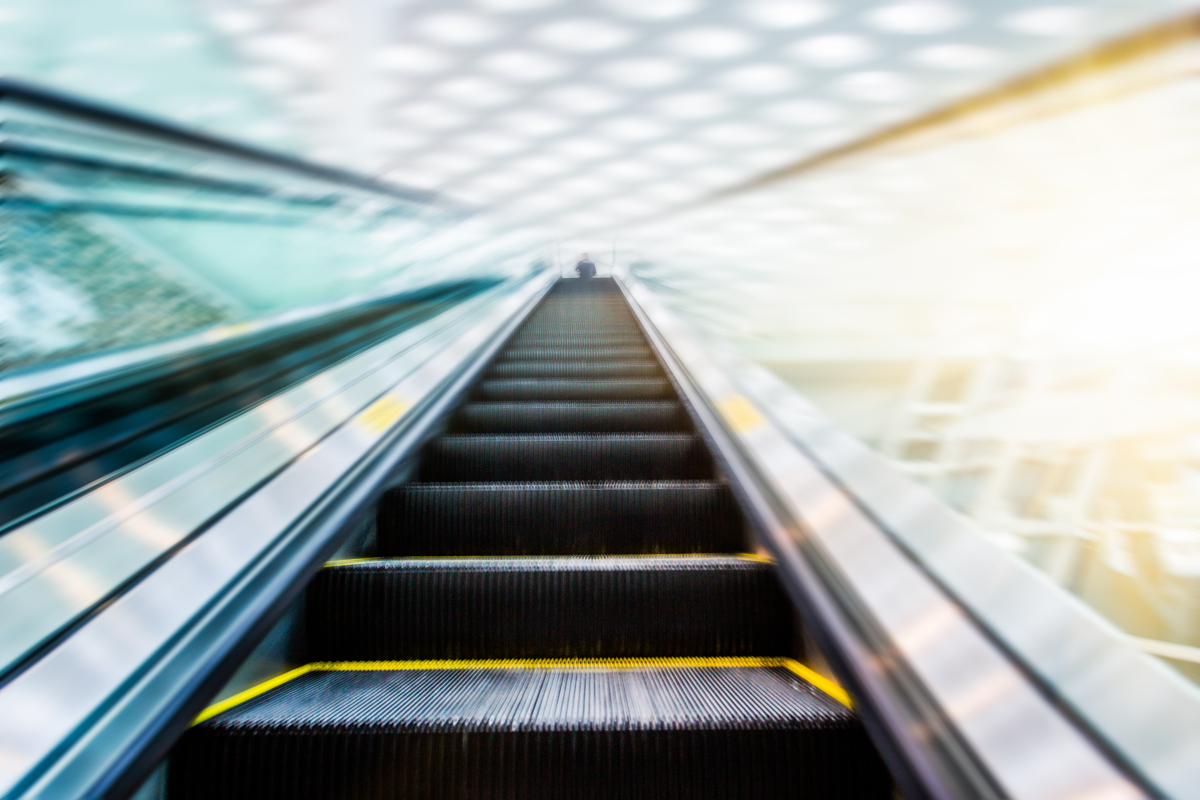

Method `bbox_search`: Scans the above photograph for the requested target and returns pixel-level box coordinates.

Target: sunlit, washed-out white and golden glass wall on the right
[624,22,1200,678]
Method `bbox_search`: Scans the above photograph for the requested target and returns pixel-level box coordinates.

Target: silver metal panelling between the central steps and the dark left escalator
[0,268,552,796]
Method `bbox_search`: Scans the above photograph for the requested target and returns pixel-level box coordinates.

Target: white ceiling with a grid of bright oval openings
[208,0,1165,233]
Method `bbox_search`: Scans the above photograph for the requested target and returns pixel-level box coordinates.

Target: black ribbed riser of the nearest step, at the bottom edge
[168,726,892,800]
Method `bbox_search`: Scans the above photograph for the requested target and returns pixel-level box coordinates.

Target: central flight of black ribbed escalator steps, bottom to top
[168,278,892,800]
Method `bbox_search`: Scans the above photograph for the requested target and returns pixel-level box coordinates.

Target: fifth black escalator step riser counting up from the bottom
[451,401,691,433]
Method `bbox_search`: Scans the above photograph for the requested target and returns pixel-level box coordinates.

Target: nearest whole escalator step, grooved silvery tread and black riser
[168,662,890,800]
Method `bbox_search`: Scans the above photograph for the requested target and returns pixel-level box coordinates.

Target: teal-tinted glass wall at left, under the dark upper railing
[0,86,530,369]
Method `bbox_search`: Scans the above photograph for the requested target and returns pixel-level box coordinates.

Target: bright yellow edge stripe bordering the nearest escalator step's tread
[192,657,853,724]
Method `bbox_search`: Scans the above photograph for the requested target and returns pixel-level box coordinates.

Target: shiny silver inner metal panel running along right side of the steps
[629,272,1152,799]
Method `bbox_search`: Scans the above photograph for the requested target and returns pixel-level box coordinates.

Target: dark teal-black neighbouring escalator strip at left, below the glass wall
[0,282,487,533]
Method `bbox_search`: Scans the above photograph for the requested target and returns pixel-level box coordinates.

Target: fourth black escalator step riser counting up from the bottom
[419,433,713,481]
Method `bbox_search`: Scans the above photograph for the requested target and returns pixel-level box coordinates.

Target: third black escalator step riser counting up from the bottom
[377,481,744,557]
